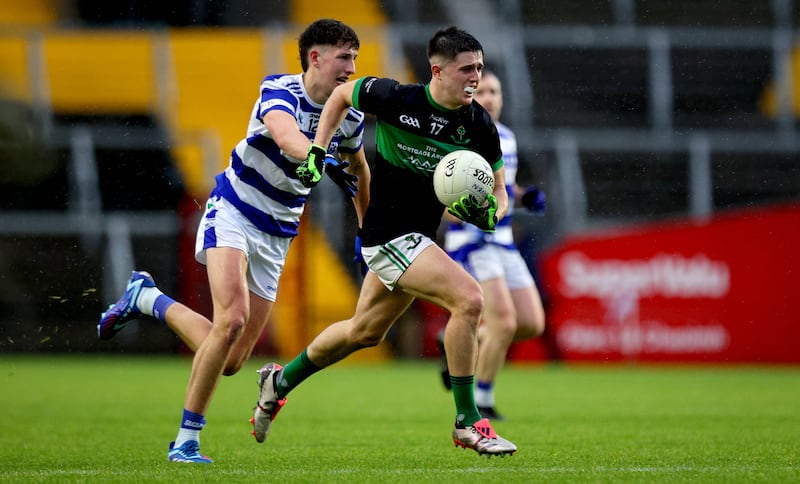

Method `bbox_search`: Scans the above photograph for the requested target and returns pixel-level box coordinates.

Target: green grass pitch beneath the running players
[0,355,800,484]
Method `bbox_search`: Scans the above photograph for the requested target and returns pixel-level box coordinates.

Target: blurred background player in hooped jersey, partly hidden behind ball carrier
[440,70,545,420]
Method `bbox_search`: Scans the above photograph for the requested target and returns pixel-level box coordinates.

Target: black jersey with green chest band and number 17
[353,77,503,247]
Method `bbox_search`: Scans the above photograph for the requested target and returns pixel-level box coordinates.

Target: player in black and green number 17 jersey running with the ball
[254,27,517,456]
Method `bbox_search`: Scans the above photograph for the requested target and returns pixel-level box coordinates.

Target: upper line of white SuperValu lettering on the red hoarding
[558,251,730,299]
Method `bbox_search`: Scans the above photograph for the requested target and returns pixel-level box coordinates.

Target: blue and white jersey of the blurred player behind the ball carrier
[444,122,519,260]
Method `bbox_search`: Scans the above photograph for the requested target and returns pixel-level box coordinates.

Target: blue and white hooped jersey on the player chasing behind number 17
[212,74,364,237]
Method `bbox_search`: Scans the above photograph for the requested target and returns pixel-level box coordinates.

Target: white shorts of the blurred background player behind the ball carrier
[462,244,534,289]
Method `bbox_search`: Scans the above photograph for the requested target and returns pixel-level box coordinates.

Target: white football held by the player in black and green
[433,150,494,207]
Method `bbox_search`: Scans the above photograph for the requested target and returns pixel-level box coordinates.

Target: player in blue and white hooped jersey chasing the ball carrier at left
[97,19,369,463]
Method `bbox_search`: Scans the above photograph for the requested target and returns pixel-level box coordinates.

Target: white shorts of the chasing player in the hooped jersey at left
[194,196,292,302]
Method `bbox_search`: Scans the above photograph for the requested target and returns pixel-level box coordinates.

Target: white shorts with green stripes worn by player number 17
[361,232,434,291]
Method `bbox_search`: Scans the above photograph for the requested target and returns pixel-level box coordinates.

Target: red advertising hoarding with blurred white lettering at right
[540,201,800,363]
